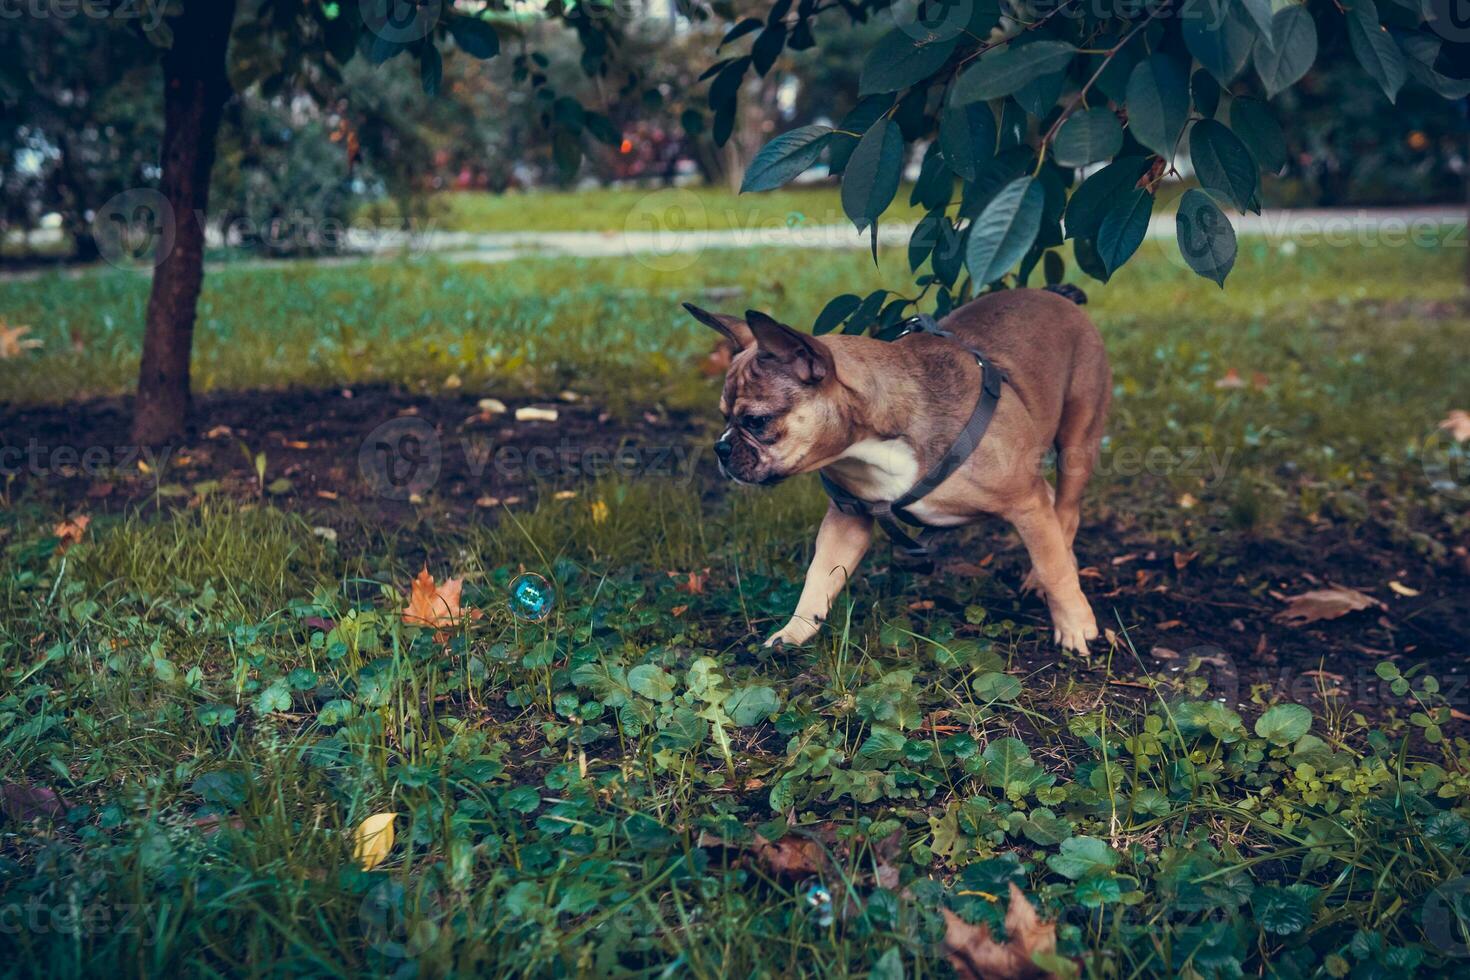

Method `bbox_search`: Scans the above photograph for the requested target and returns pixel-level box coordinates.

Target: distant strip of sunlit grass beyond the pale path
[362,184,923,232]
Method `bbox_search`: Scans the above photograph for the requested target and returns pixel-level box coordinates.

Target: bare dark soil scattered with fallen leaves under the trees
[0,386,1470,716]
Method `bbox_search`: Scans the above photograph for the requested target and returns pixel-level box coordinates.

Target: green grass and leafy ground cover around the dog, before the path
[0,232,1470,977]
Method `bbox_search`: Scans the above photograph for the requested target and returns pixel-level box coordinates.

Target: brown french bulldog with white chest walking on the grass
[685,289,1113,654]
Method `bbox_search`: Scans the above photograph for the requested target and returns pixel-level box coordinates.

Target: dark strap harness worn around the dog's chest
[819,313,1007,569]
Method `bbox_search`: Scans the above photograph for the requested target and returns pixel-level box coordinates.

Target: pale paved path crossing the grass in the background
[0,207,1466,281]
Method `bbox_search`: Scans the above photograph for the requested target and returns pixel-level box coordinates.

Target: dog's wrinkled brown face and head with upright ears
[685,304,842,485]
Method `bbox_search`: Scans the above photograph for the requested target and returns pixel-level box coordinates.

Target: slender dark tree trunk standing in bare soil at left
[132,0,235,445]
